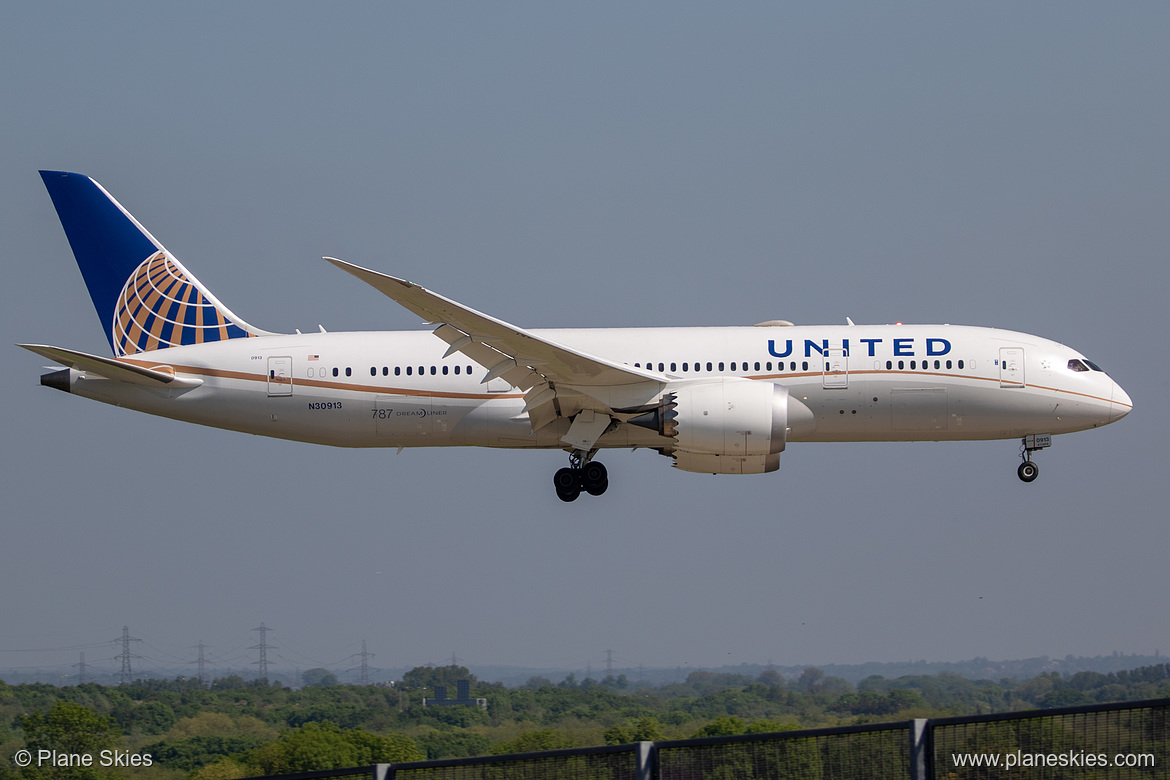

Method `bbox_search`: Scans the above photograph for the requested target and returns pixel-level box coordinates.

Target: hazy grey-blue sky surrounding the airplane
[0,2,1170,669]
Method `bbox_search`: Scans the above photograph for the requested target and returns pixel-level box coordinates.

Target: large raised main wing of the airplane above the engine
[325,257,669,430]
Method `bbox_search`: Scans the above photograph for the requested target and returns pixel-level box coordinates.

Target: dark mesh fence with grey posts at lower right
[239,699,1170,780]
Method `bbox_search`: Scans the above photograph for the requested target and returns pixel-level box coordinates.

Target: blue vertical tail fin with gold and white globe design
[41,171,266,358]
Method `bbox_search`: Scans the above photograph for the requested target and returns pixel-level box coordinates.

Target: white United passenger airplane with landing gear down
[19,171,1133,502]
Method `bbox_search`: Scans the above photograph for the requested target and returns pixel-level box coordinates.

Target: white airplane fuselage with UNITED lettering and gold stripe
[70,325,1131,448]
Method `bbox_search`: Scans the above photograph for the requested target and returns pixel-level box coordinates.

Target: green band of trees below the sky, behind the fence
[0,664,1170,780]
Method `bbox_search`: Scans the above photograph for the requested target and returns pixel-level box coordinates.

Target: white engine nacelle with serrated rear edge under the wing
[629,378,799,474]
